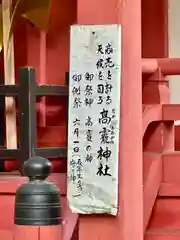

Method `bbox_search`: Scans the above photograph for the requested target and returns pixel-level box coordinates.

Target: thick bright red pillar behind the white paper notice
[77,0,143,240]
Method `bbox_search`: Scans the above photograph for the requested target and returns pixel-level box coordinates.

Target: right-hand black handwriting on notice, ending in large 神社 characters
[96,43,115,176]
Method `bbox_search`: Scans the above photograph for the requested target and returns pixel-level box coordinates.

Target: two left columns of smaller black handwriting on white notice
[69,69,94,193]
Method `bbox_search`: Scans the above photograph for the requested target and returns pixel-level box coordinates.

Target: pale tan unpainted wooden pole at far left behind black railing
[2,0,17,149]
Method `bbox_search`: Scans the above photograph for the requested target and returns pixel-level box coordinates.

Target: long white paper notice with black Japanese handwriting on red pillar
[68,25,121,215]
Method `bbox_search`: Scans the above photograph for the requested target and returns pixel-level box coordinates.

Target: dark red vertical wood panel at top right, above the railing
[142,0,168,58]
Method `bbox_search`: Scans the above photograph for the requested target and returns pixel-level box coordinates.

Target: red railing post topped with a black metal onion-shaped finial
[13,157,63,240]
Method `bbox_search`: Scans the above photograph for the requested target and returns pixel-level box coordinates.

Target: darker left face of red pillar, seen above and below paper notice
[77,0,122,240]
